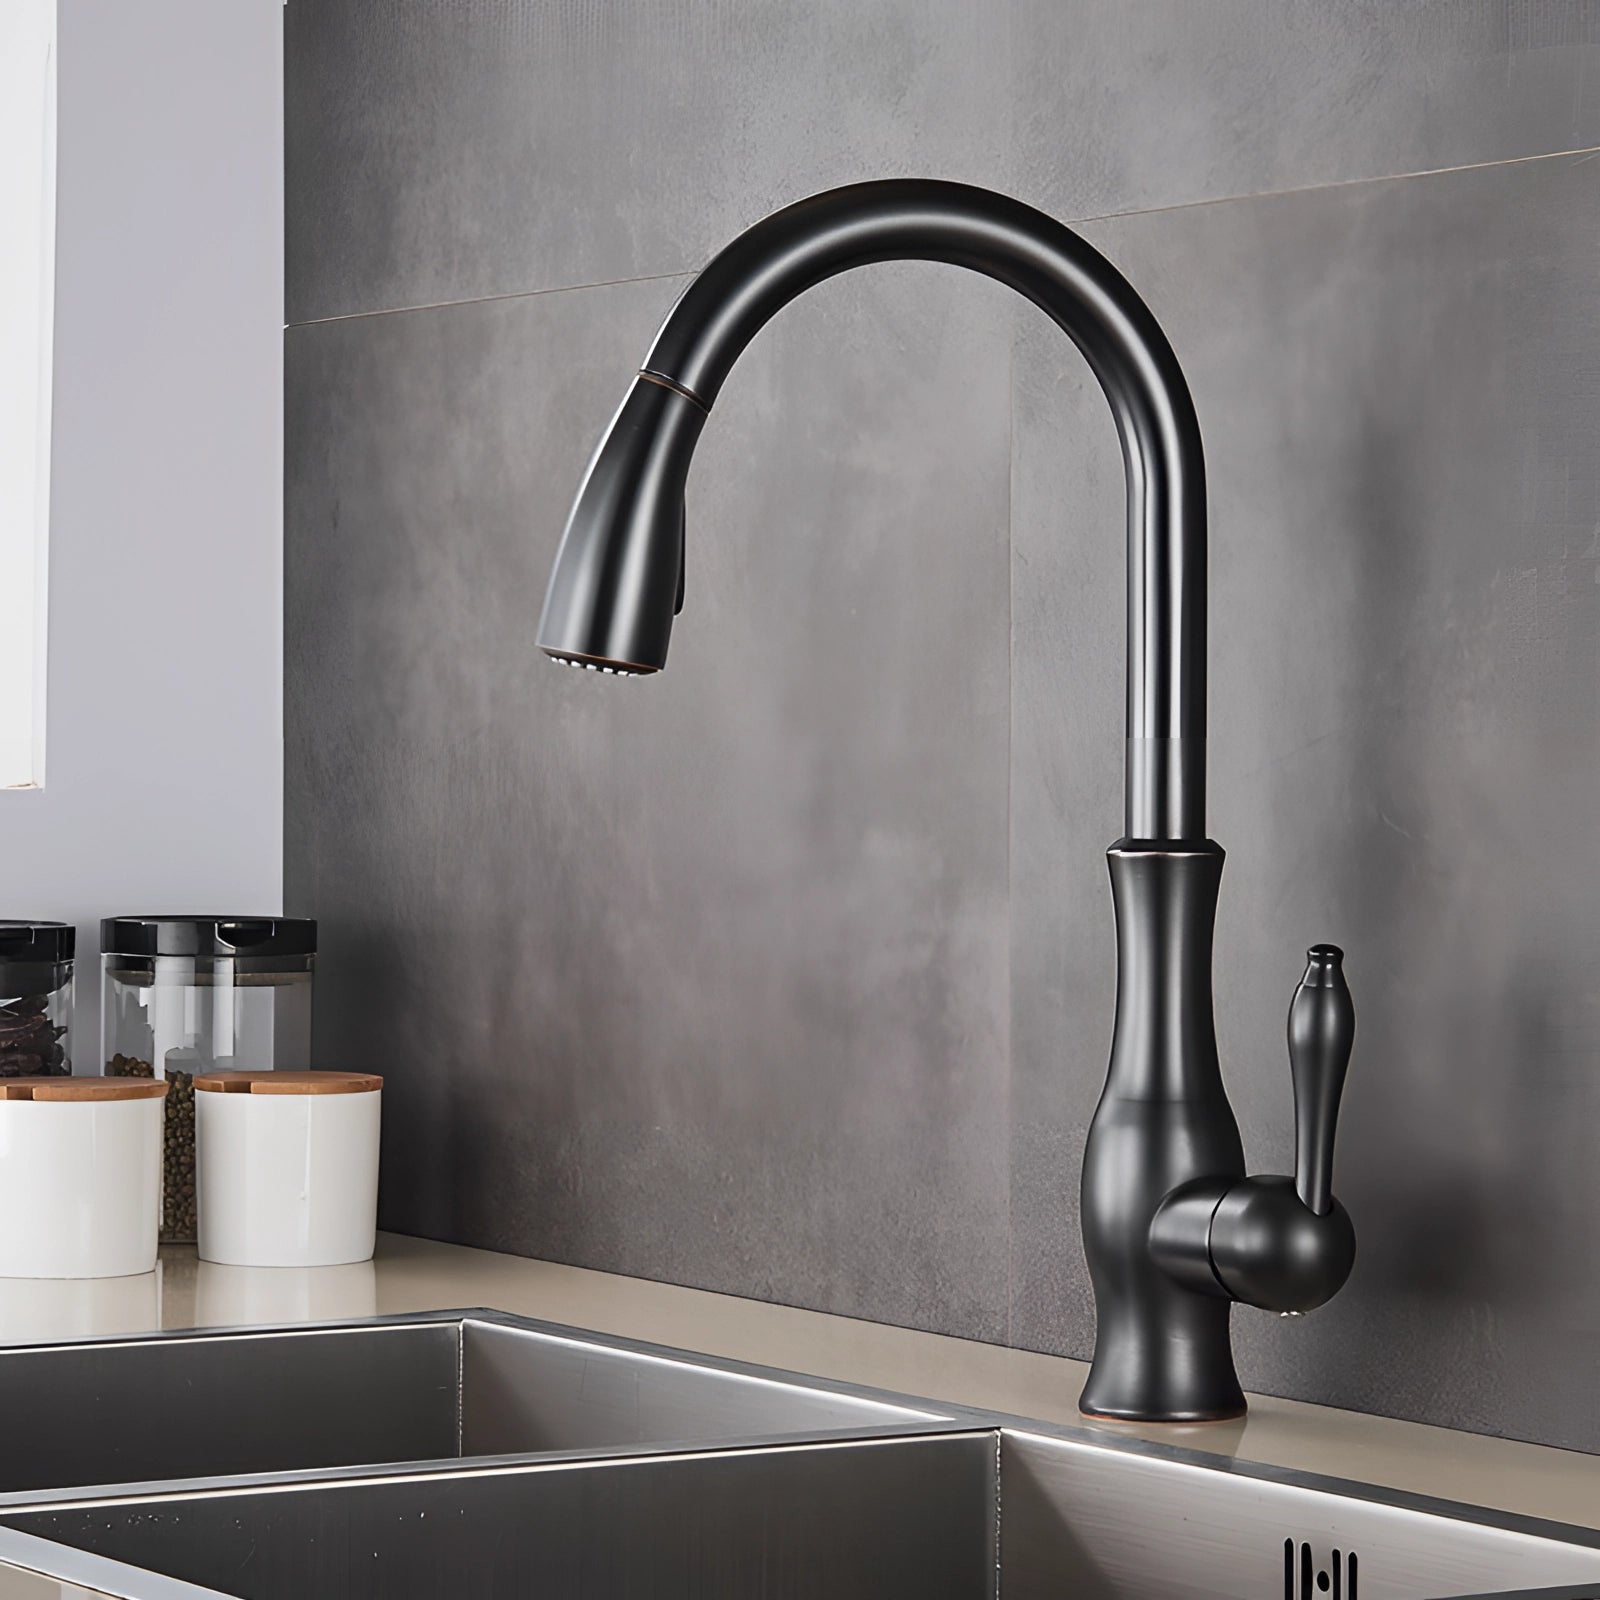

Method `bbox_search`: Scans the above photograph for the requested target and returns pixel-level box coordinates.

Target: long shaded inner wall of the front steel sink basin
[0,1434,995,1600]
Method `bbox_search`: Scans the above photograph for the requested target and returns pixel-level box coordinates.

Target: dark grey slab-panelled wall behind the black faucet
[286,0,1600,1450]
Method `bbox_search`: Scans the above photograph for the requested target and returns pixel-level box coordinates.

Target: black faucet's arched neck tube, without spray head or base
[643,179,1206,840]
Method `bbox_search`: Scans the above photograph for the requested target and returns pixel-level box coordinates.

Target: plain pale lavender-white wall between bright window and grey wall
[0,0,283,1072]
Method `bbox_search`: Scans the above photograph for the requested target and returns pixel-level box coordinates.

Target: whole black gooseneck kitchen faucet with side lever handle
[539,179,1355,1422]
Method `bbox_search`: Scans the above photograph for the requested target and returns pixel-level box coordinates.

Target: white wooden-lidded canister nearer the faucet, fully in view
[194,1072,384,1267]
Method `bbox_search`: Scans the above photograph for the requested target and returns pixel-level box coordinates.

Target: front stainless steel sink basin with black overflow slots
[12,1427,1600,1600]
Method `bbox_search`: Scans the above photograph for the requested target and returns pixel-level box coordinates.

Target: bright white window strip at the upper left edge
[0,0,56,789]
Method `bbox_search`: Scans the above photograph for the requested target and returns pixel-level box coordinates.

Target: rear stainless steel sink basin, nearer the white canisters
[0,1312,941,1506]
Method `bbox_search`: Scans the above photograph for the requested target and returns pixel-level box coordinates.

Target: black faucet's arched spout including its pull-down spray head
[539,179,1206,838]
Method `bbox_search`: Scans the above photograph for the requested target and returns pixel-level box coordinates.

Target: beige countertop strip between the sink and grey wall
[0,1234,1600,1528]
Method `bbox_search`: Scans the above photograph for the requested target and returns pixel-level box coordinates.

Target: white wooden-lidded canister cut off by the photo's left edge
[0,1077,166,1278]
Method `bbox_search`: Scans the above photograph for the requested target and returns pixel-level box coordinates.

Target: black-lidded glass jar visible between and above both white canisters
[101,917,317,1243]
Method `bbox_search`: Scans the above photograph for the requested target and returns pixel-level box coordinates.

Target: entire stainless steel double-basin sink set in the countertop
[0,1310,1600,1600]
